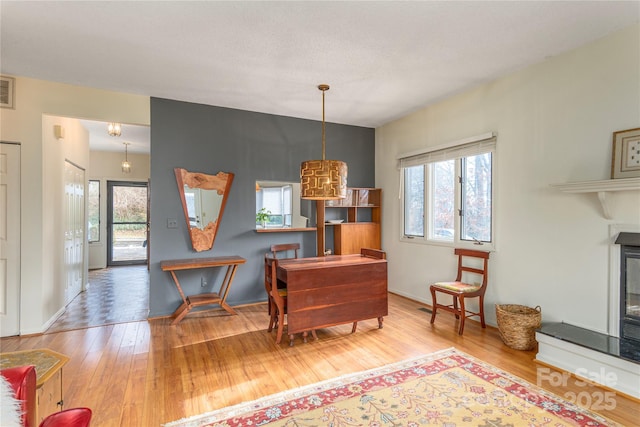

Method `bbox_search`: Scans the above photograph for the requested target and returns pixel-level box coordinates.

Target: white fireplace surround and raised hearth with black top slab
[536,229,640,399]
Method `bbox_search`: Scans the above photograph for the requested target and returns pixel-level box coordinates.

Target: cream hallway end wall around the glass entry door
[88,151,151,269]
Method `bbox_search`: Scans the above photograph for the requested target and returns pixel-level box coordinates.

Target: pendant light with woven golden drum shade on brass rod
[300,84,347,200]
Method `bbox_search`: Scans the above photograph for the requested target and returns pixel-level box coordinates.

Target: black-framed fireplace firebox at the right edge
[616,232,640,342]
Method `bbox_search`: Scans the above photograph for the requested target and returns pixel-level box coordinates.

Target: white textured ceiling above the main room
[0,0,640,153]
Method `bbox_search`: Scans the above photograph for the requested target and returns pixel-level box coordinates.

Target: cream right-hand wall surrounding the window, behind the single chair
[376,25,640,332]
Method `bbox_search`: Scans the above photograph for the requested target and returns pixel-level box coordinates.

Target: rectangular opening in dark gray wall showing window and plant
[256,181,309,229]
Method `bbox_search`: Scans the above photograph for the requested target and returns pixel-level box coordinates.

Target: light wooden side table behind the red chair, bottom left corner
[0,348,69,424]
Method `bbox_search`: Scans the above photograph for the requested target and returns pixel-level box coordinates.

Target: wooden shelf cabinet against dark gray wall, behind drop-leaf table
[322,188,382,255]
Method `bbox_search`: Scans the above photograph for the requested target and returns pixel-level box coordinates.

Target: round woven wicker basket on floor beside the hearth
[496,304,542,350]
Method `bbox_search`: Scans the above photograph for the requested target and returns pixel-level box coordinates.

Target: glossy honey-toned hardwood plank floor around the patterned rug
[0,295,640,427]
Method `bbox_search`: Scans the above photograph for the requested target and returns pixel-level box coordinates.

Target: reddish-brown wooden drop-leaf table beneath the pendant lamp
[277,254,388,343]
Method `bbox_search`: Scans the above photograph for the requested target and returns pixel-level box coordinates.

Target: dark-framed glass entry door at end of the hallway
[107,181,149,267]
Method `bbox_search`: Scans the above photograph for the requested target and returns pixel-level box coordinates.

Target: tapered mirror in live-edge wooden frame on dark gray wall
[174,168,234,252]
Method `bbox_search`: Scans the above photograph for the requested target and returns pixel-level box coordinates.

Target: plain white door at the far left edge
[0,142,20,337]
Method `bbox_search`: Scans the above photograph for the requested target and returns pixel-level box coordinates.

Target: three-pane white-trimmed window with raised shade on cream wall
[399,133,496,246]
